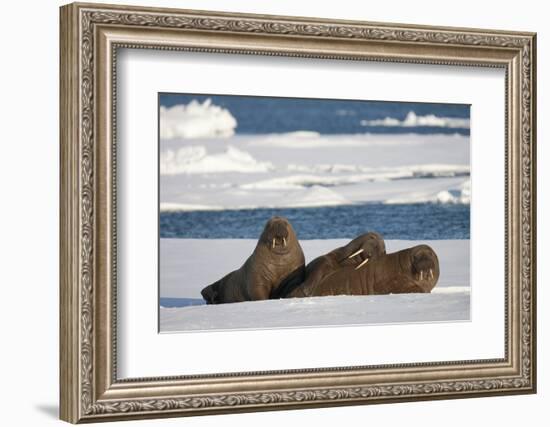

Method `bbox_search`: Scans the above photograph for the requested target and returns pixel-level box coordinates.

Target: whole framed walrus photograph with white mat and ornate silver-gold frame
[60,4,536,423]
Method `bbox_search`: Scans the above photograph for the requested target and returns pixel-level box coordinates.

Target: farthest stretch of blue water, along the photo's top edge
[159,94,470,135]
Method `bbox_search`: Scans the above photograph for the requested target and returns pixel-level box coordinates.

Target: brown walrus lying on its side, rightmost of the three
[289,245,439,297]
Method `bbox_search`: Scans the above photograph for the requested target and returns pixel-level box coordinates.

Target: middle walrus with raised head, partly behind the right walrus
[274,232,386,298]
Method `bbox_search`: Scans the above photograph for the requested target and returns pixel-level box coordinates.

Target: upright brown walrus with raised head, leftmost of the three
[201,216,305,304]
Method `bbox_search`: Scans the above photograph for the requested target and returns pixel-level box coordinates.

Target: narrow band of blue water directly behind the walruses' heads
[160,203,470,240]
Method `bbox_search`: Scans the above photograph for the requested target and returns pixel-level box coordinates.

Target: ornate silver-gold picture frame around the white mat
[60,4,536,423]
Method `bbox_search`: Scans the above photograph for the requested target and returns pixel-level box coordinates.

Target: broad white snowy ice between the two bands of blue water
[160,131,470,210]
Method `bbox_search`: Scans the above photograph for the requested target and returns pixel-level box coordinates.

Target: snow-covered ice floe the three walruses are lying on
[160,239,470,332]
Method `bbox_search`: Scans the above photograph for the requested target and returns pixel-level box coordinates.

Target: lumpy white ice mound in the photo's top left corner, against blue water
[160,99,237,139]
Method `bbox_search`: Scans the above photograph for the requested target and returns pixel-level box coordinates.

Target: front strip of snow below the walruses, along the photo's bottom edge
[160,292,469,332]
